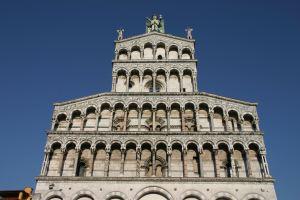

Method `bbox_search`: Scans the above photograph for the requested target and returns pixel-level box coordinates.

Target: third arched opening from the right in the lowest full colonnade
[218,143,232,177]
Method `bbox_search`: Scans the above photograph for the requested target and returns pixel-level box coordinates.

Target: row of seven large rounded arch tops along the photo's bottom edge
[45,186,266,200]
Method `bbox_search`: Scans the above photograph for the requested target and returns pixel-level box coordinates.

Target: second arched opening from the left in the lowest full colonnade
[62,143,76,176]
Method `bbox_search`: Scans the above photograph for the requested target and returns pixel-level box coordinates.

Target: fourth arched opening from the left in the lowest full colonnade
[93,143,106,177]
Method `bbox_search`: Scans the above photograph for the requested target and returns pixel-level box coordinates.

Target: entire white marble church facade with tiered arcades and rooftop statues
[33,16,276,200]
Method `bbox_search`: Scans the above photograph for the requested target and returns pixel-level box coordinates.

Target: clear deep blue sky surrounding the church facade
[0,0,300,200]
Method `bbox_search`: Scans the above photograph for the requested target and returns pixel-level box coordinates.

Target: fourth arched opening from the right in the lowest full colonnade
[201,143,216,177]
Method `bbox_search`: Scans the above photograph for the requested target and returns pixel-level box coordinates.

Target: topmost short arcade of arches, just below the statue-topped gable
[115,42,194,60]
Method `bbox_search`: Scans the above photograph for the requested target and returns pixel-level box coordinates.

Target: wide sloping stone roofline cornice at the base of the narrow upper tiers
[53,92,258,106]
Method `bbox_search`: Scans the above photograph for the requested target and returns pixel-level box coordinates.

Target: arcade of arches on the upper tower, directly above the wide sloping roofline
[112,69,197,92]
